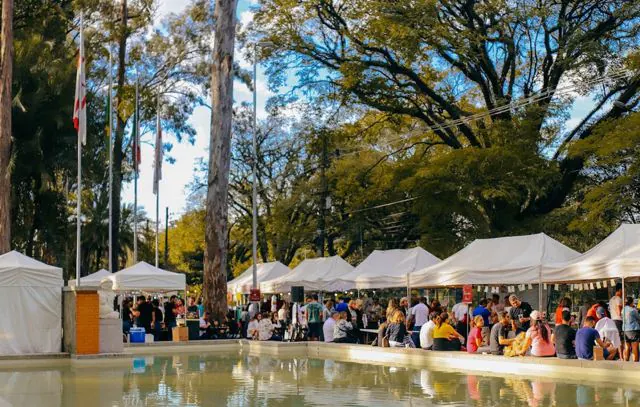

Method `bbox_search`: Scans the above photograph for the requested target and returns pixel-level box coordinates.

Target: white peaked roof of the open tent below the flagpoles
[102,261,187,291]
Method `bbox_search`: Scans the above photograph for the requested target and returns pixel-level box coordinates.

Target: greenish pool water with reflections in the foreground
[0,353,640,407]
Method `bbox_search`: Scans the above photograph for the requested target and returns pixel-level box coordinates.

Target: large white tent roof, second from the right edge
[411,233,580,287]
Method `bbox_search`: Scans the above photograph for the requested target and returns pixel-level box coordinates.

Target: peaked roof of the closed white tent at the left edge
[0,250,64,287]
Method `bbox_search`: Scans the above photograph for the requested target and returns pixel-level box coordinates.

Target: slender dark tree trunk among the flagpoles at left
[110,0,129,271]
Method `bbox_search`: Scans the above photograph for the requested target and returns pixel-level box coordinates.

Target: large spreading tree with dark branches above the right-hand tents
[255,0,640,245]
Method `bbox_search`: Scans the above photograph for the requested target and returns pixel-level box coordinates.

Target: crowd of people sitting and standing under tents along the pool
[123,286,640,361]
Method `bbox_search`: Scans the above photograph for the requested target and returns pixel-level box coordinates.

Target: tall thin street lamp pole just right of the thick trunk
[251,41,273,289]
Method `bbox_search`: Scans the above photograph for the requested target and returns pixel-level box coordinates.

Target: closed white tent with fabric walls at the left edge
[0,251,64,355]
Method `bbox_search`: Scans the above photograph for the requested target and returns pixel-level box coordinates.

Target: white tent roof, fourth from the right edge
[260,256,354,293]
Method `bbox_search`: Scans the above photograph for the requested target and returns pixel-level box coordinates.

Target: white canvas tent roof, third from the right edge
[350,247,440,290]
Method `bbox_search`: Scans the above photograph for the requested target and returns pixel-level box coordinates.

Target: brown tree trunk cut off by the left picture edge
[0,0,13,254]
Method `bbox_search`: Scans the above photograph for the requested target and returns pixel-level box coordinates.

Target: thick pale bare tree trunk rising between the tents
[203,0,236,318]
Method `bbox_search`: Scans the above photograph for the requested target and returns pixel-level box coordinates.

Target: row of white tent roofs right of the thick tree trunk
[227,224,640,293]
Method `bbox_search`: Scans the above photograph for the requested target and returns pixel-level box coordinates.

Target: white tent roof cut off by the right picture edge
[542,224,640,282]
